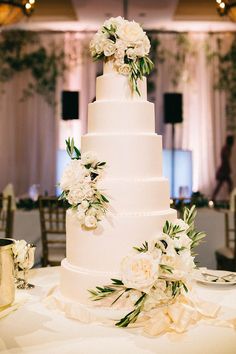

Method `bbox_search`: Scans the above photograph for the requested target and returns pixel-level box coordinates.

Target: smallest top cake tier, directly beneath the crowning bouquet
[96,61,147,101]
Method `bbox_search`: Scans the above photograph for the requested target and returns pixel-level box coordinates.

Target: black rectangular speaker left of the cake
[61,91,79,120]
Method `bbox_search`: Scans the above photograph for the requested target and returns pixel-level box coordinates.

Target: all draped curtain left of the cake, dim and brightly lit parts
[0,33,96,195]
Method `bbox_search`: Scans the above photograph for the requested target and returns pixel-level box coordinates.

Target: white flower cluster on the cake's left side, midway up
[59,138,109,229]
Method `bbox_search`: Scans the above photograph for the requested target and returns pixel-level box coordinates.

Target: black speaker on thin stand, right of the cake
[164,93,183,196]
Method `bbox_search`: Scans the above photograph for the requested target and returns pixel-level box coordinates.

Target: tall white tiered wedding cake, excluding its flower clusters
[60,62,176,304]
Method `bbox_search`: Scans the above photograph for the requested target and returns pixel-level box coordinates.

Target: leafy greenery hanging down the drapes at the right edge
[206,33,236,132]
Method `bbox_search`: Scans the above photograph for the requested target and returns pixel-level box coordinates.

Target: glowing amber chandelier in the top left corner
[0,0,35,26]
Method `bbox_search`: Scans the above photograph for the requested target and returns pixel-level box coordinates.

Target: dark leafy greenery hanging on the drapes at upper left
[0,30,66,105]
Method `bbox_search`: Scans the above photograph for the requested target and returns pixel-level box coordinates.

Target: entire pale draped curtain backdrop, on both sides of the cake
[0,32,236,196]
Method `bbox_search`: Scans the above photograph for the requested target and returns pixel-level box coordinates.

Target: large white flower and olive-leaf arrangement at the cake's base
[89,206,205,334]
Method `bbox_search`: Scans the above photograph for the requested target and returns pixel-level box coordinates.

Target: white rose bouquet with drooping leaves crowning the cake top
[90,16,153,95]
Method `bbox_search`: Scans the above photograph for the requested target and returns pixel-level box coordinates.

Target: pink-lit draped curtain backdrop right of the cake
[152,33,235,197]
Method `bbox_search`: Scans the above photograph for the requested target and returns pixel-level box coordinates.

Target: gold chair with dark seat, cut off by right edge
[215,196,236,272]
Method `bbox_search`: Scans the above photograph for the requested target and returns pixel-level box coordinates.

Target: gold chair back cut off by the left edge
[0,194,14,238]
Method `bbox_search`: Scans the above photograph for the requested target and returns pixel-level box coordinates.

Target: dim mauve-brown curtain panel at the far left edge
[0,68,56,195]
